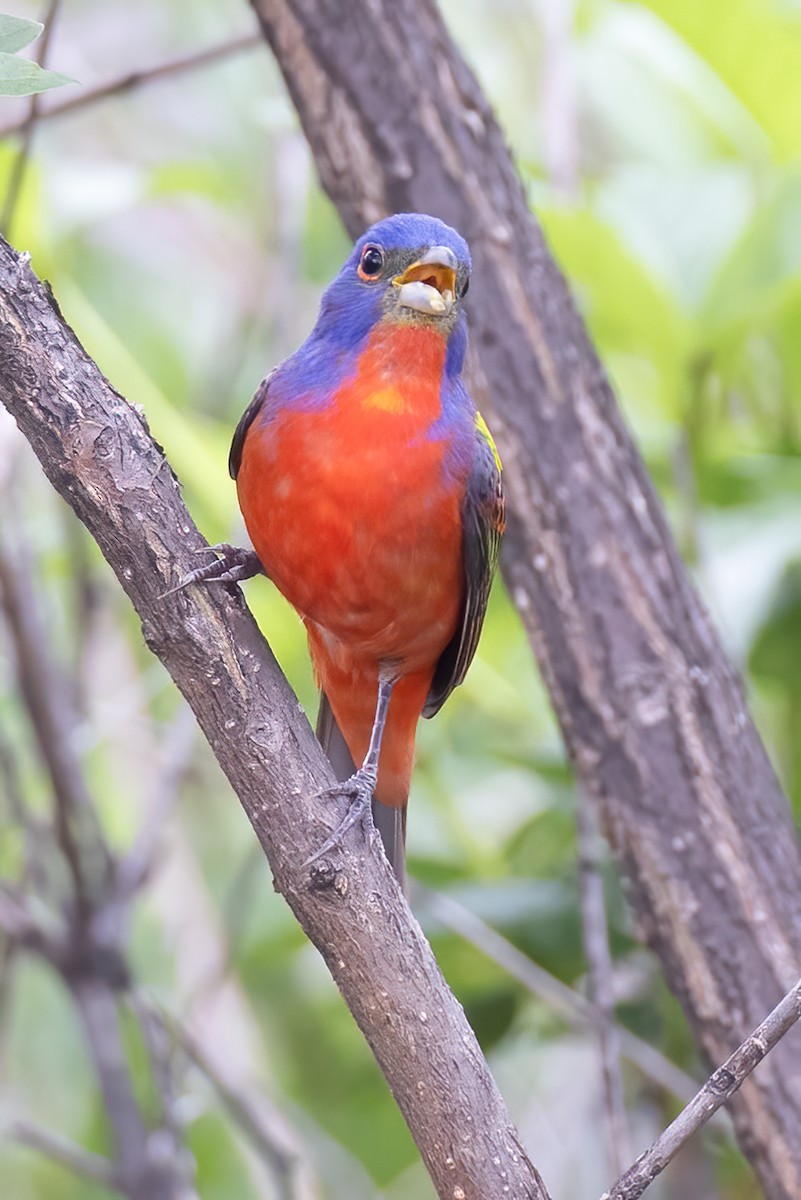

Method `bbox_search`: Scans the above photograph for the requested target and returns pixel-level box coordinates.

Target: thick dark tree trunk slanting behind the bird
[252,0,801,1200]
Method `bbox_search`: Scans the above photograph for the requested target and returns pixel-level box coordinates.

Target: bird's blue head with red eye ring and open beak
[313,212,471,373]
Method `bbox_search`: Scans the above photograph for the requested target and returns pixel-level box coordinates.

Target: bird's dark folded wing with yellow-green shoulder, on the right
[423,413,505,716]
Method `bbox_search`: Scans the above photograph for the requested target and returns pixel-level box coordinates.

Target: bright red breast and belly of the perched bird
[237,328,463,671]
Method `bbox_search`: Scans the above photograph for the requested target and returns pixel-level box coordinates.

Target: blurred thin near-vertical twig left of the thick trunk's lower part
[578,788,632,1176]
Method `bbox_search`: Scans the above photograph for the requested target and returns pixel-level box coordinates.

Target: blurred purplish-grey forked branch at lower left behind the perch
[0,487,194,1200]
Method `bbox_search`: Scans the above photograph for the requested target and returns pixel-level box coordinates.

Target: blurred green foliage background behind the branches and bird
[0,0,801,1200]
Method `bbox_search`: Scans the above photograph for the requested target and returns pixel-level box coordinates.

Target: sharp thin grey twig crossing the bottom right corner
[601,979,801,1200]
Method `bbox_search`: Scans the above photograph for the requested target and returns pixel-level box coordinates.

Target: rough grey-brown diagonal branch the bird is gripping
[0,239,548,1200]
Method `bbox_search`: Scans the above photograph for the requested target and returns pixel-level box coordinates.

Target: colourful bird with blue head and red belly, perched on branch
[179,212,505,887]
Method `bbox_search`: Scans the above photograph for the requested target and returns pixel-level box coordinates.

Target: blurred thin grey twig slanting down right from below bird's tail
[411,882,698,1102]
